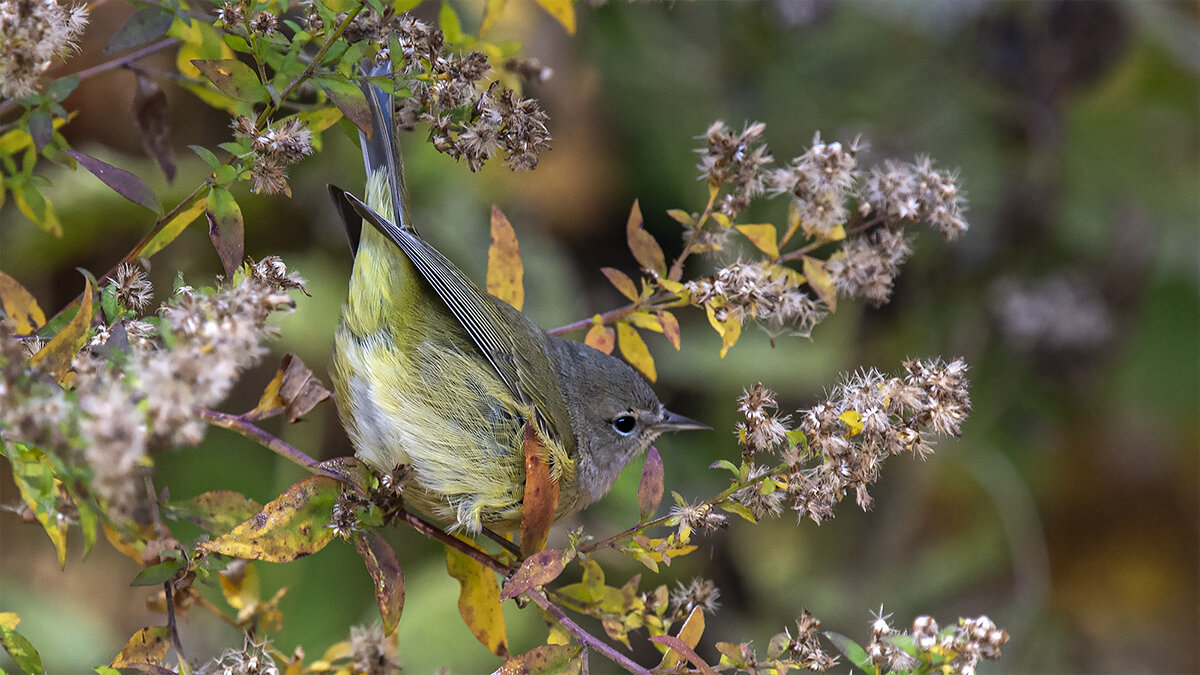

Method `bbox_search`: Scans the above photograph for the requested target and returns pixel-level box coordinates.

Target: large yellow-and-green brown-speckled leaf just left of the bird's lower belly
[197,476,342,562]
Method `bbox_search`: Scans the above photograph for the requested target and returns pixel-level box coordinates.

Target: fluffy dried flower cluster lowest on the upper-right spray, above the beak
[684,261,828,336]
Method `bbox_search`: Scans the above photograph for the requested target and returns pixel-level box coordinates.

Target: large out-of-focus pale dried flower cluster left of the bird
[0,258,301,520]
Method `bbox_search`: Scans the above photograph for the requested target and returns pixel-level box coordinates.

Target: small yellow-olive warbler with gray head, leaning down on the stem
[329,70,708,532]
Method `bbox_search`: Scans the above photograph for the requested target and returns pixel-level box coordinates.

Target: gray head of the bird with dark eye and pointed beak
[547,336,708,508]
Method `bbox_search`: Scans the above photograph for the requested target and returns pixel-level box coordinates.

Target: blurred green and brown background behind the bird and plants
[0,0,1200,673]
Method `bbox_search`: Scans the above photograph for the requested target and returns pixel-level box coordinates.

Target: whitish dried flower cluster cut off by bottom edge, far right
[865,609,1008,675]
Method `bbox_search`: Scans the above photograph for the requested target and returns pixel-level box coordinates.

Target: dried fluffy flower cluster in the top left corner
[0,0,88,98]
